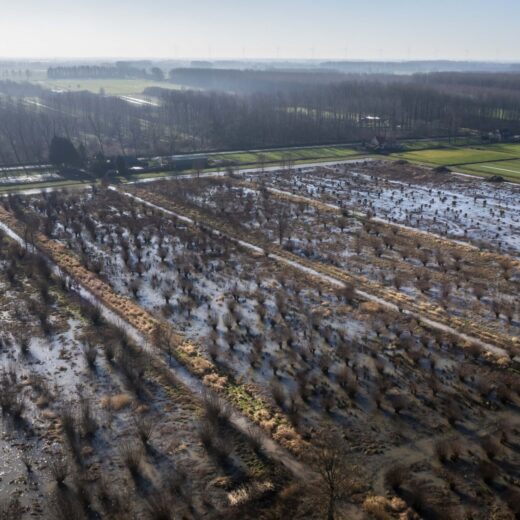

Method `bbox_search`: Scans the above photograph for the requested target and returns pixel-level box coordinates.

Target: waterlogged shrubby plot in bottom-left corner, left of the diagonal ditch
[0,226,290,519]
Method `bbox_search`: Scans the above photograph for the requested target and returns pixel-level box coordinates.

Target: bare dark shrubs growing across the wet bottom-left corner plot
[0,235,296,520]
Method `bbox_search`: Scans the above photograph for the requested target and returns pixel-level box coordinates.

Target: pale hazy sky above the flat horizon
[0,0,520,61]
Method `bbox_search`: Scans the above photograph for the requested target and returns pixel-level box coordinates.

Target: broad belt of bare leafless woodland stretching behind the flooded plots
[0,69,520,164]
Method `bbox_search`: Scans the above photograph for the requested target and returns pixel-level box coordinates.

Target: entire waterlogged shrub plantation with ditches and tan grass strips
[0,161,520,520]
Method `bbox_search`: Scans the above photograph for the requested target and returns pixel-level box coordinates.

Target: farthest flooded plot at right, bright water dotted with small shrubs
[243,160,520,256]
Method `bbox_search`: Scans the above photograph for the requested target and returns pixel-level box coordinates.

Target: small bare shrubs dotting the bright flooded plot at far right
[298,161,516,252]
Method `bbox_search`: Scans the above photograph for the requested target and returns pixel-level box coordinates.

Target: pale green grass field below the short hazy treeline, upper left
[35,79,181,96]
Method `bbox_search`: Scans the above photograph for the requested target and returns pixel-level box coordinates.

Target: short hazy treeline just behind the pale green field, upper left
[47,62,164,80]
